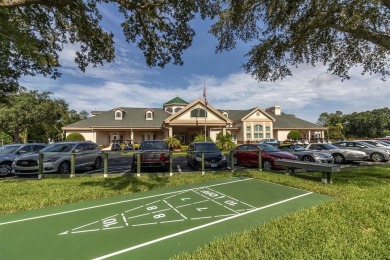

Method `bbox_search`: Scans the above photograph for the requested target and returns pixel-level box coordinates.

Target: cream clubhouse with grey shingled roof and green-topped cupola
[62,97,327,145]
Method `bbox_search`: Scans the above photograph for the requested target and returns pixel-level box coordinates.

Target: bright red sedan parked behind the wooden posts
[232,143,298,171]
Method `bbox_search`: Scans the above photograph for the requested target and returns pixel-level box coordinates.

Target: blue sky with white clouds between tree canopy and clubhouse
[20,6,390,123]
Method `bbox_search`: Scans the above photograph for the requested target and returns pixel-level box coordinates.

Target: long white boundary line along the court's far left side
[0,178,254,226]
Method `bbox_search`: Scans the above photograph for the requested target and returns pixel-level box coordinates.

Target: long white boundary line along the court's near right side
[93,192,313,260]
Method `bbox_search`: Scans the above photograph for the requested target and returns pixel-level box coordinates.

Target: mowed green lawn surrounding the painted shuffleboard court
[0,166,390,259]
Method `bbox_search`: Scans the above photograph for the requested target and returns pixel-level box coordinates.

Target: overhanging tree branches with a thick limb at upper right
[211,0,390,81]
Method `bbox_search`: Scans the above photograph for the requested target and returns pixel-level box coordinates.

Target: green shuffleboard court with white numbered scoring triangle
[0,178,332,259]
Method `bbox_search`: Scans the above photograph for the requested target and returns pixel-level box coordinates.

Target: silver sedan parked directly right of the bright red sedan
[279,144,333,163]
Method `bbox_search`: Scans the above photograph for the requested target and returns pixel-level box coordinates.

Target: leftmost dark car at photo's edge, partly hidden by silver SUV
[0,143,47,177]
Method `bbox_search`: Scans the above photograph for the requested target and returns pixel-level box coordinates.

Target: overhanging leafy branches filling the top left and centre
[0,0,218,98]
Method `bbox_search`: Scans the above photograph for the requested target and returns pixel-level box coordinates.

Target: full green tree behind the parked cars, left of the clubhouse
[0,90,88,143]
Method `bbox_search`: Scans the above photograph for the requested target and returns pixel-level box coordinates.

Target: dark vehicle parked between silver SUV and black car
[131,140,170,172]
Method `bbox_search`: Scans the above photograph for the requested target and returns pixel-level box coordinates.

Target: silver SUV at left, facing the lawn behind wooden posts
[12,142,103,176]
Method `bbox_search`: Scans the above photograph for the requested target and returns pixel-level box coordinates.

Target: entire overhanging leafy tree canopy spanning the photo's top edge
[0,0,390,99]
